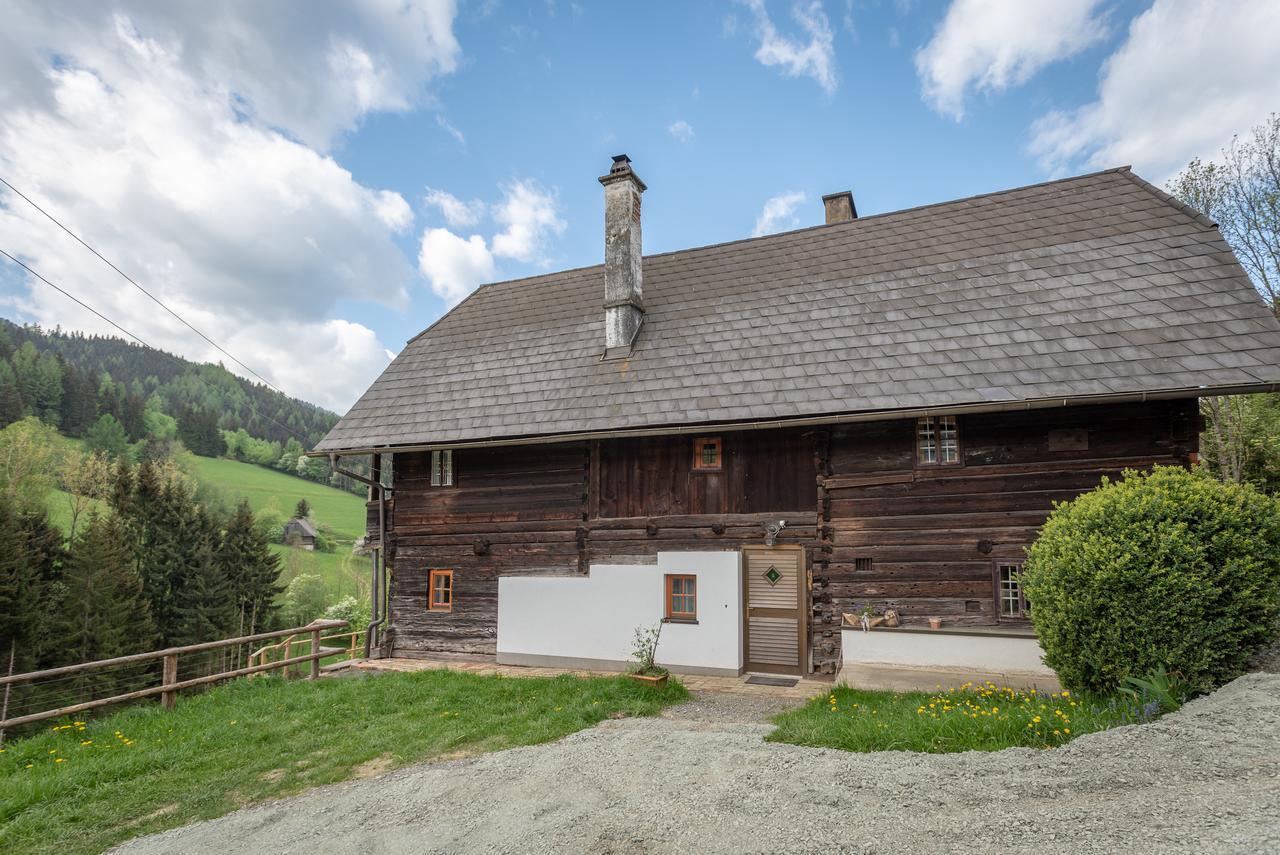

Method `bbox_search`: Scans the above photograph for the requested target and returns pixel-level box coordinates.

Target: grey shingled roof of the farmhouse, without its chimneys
[316,168,1280,452]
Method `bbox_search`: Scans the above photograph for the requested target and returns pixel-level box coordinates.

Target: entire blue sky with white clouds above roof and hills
[0,0,1280,411]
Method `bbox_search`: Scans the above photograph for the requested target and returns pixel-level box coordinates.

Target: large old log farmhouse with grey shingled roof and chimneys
[315,156,1280,687]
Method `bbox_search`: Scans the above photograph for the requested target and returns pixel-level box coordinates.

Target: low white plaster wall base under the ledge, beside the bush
[841,627,1053,676]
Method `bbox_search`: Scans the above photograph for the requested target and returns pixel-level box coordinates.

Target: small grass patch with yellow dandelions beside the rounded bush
[768,683,1135,754]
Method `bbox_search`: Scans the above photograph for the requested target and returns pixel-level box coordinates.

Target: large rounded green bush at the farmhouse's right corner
[1023,466,1280,692]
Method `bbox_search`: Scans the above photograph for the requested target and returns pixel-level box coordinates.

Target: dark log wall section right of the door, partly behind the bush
[810,401,1198,673]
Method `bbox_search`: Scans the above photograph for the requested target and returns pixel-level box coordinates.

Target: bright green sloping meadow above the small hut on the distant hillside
[196,457,365,543]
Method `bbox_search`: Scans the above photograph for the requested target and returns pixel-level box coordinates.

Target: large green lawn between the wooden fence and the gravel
[0,671,687,855]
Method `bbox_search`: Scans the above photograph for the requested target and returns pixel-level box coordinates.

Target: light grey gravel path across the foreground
[110,673,1280,855]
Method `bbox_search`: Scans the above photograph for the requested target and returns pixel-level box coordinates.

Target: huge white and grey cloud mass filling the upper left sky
[0,3,457,410]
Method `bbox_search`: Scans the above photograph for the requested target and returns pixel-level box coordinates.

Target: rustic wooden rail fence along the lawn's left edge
[0,621,356,741]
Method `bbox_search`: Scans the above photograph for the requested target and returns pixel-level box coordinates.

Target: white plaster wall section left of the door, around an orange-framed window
[498,552,742,675]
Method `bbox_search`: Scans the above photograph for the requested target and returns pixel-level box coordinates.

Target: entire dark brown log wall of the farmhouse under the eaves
[372,401,1198,675]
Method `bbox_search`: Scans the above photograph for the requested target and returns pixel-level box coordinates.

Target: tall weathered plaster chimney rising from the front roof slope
[600,155,645,356]
